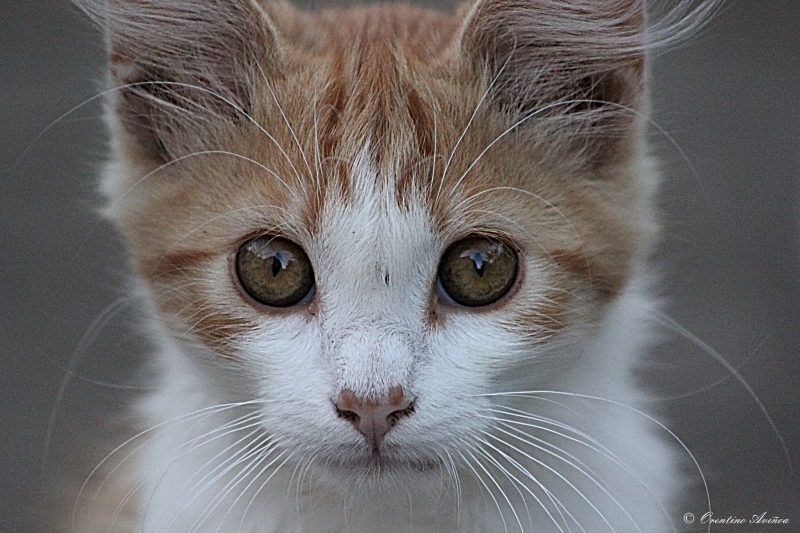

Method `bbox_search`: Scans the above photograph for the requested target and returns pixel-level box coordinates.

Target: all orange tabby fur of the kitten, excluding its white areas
[67,0,688,532]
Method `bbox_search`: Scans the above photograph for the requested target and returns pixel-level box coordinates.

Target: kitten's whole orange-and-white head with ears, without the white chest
[97,0,652,486]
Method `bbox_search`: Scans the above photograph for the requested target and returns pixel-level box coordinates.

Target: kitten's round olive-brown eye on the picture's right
[439,237,519,307]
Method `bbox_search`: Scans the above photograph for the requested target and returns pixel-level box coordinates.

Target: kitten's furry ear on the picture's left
[76,0,282,161]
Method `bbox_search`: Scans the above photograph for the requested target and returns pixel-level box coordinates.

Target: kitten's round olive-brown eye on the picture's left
[236,236,314,307]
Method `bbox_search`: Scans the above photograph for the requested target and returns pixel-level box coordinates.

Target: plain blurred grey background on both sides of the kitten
[0,0,800,533]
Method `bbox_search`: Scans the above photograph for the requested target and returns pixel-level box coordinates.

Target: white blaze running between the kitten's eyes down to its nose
[315,150,438,398]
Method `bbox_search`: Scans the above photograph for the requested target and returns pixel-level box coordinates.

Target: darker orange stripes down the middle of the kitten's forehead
[304,30,441,202]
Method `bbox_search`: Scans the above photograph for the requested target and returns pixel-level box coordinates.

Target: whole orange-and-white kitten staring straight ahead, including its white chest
[71,0,710,533]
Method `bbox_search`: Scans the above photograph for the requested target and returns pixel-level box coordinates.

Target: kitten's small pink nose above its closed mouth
[336,387,414,450]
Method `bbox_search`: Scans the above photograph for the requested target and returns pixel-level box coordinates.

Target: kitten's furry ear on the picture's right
[457,0,646,162]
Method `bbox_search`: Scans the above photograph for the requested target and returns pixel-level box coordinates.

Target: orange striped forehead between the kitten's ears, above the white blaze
[235,5,506,208]
